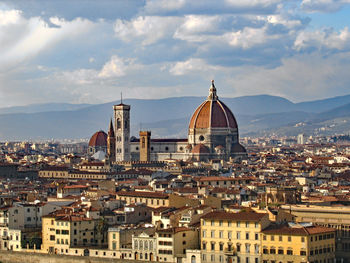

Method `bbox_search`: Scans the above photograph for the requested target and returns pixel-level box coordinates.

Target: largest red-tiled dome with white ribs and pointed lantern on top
[189,81,237,129]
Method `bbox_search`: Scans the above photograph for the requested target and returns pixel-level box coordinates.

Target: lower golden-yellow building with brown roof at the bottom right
[261,224,335,263]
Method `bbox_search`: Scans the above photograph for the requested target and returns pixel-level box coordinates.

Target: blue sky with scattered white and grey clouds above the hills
[0,0,350,107]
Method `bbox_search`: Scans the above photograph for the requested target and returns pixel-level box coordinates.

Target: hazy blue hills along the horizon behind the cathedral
[0,95,350,140]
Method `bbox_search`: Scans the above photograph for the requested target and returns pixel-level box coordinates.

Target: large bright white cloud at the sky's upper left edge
[0,10,94,72]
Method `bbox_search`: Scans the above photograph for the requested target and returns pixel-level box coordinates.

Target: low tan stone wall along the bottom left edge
[0,250,150,263]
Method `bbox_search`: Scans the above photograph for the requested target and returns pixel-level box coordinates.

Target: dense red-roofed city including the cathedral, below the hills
[0,89,350,263]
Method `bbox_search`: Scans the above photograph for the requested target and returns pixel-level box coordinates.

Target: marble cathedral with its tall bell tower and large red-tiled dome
[95,80,247,162]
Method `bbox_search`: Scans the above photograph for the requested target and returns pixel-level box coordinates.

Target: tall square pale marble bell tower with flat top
[113,101,130,162]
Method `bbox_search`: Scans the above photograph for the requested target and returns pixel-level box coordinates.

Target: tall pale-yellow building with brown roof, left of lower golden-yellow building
[200,211,270,263]
